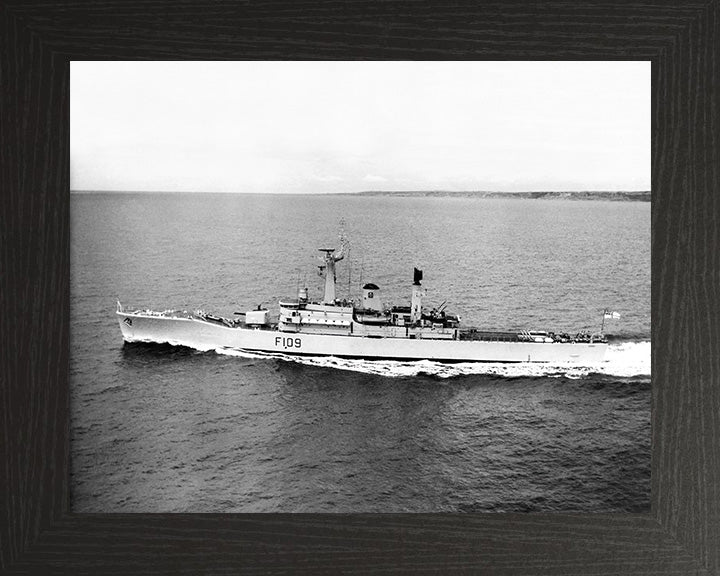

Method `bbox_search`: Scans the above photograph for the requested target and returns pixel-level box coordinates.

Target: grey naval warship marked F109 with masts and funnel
[116,236,607,366]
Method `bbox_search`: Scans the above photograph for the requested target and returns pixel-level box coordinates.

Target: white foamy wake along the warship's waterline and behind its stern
[215,341,651,379]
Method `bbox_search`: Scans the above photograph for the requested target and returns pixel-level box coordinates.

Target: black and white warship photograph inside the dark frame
[69,61,652,513]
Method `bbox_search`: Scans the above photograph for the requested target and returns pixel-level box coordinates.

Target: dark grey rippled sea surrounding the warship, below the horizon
[70,193,651,512]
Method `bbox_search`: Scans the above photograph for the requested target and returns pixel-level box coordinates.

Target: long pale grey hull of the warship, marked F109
[116,312,607,366]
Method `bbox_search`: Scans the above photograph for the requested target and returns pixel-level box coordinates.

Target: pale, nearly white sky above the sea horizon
[70,62,651,194]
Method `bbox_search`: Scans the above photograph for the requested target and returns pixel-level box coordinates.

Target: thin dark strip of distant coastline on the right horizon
[346,190,650,202]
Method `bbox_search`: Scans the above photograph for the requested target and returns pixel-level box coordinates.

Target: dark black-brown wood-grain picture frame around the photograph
[0,0,720,575]
